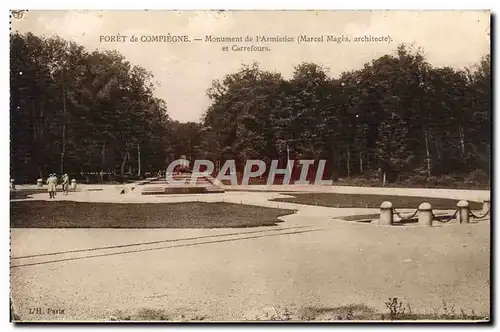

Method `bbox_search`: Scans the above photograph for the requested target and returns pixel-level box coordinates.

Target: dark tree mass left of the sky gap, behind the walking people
[10,33,190,182]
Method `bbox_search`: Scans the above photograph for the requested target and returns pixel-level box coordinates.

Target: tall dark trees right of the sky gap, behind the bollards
[198,45,491,182]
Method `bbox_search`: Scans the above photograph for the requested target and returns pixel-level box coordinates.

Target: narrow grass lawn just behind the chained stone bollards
[273,193,483,210]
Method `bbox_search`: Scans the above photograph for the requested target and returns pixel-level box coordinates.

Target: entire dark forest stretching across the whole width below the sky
[10,33,491,186]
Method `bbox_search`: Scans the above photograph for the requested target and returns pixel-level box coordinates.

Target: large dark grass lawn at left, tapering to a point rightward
[10,201,293,228]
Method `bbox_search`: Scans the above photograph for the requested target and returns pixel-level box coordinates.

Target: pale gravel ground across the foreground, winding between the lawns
[11,188,490,321]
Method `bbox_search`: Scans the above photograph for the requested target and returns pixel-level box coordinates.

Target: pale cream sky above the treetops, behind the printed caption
[11,10,490,122]
